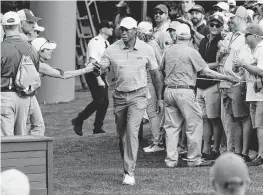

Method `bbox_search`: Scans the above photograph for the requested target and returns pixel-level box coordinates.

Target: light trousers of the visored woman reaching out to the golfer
[27,96,45,136]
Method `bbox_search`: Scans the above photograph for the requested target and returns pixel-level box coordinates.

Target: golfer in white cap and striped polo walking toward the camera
[90,17,163,185]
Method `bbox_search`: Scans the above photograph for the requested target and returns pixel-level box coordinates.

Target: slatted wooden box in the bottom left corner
[1,136,54,195]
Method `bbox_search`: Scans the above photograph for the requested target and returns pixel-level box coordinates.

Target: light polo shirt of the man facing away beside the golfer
[161,43,208,86]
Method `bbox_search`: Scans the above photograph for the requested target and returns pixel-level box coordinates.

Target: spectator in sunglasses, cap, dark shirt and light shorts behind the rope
[197,15,224,160]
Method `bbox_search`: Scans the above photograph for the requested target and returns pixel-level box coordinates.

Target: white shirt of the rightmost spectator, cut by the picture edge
[243,41,263,101]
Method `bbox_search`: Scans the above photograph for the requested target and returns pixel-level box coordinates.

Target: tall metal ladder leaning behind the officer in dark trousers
[75,0,100,89]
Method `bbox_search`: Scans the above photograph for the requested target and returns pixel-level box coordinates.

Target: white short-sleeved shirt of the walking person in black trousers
[87,34,110,62]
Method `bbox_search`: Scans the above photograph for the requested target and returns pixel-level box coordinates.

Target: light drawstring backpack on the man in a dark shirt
[11,45,41,97]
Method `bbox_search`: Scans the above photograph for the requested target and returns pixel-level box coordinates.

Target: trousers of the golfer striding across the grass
[113,88,148,176]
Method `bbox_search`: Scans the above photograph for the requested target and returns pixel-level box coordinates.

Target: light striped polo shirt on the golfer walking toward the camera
[99,38,158,92]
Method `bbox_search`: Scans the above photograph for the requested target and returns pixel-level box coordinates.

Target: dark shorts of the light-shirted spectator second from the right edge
[221,85,250,118]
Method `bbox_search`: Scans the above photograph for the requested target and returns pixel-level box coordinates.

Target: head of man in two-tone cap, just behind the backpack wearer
[17,9,41,36]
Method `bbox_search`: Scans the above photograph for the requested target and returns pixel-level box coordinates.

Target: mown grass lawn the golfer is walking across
[41,91,263,195]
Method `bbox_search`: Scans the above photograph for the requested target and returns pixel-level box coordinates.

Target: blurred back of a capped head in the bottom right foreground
[210,152,250,195]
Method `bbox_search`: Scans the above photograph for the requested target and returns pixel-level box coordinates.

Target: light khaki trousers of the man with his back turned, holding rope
[164,88,203,167]
